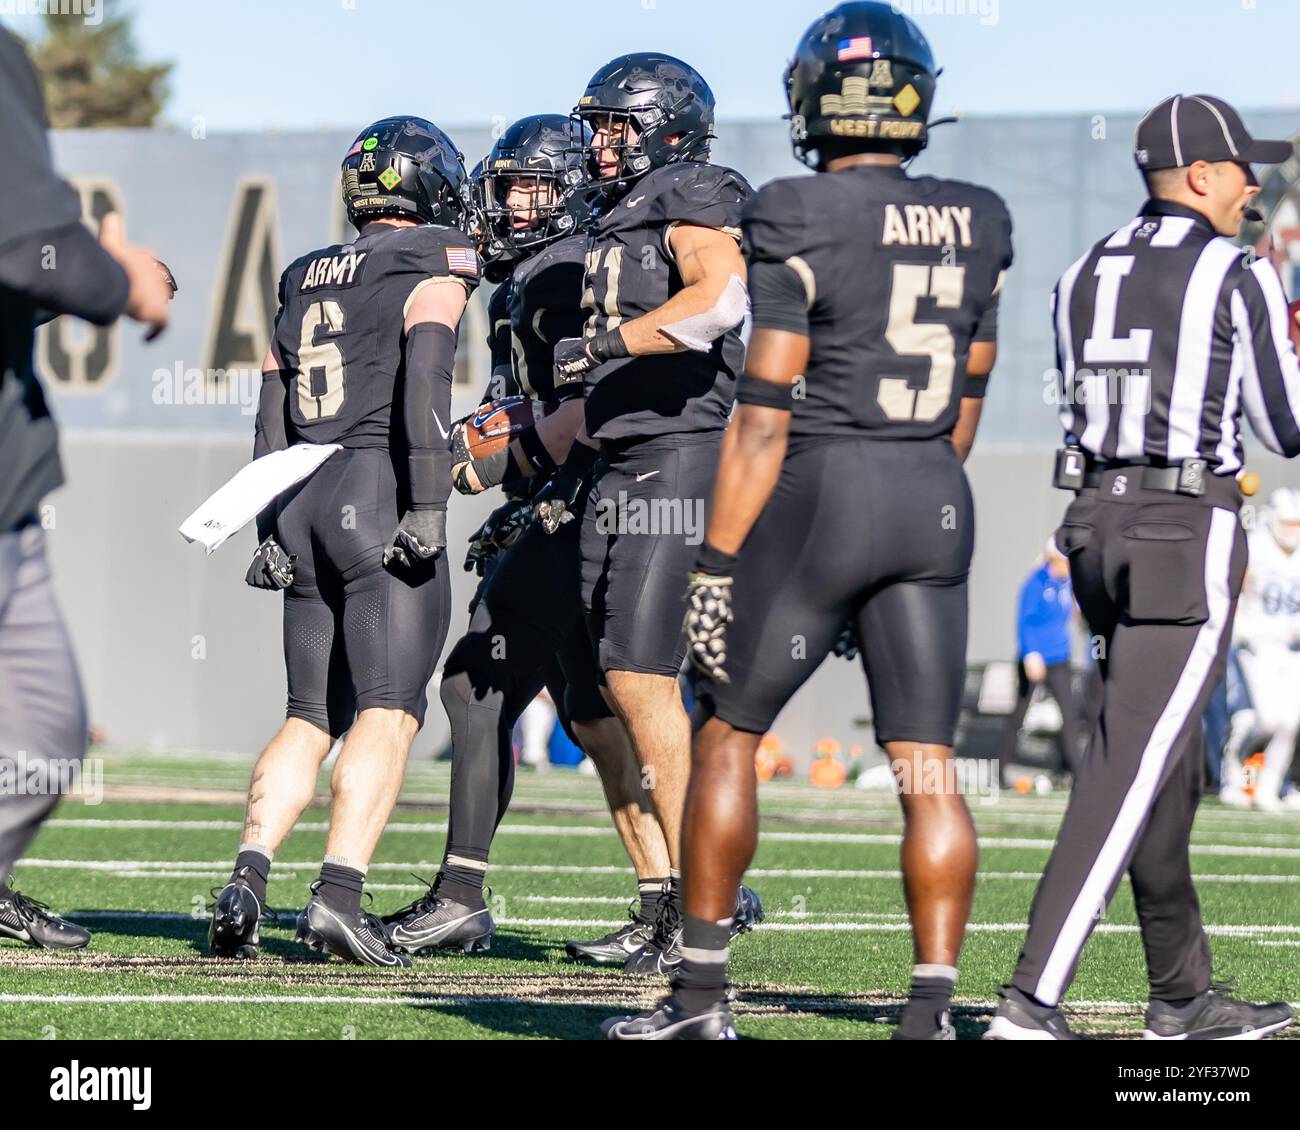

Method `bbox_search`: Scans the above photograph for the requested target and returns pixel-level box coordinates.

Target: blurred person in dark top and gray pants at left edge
[0,27,176,949]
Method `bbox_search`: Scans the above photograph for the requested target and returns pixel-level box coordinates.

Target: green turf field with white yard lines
[0,753,1300,1039]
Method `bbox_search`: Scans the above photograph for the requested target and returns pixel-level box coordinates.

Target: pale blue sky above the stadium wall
[12,0,1300,131]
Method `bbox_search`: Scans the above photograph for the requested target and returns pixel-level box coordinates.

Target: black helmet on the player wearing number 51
[573,51,716,194]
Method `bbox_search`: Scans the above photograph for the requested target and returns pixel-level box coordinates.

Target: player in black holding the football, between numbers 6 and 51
[385,114,668,964]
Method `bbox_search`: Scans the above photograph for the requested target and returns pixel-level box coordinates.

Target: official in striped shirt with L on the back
[985,95,1300,1040]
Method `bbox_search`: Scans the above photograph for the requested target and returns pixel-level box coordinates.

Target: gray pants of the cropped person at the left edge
[0,523,86,884]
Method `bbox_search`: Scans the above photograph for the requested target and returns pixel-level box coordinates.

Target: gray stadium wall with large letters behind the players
[40,113,1300,752]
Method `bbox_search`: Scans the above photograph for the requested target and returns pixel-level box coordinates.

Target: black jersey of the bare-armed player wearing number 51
[582,161,753,441]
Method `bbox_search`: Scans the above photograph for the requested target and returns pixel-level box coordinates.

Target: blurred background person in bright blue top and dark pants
[997,540,1079,775]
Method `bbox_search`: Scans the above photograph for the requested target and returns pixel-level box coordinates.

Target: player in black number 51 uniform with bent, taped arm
[537,52,759,973]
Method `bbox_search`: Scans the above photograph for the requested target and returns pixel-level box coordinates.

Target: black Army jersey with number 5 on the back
[745,165,1011,440]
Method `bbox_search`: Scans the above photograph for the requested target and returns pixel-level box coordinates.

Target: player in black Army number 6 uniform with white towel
[209,117,478,966]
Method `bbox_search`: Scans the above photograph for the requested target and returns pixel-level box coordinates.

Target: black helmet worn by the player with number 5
[785,3,939,169]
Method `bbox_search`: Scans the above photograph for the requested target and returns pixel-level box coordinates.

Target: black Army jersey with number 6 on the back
[276,224,478,447]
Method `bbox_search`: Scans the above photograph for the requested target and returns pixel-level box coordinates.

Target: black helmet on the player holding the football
[469,114,592,264]
